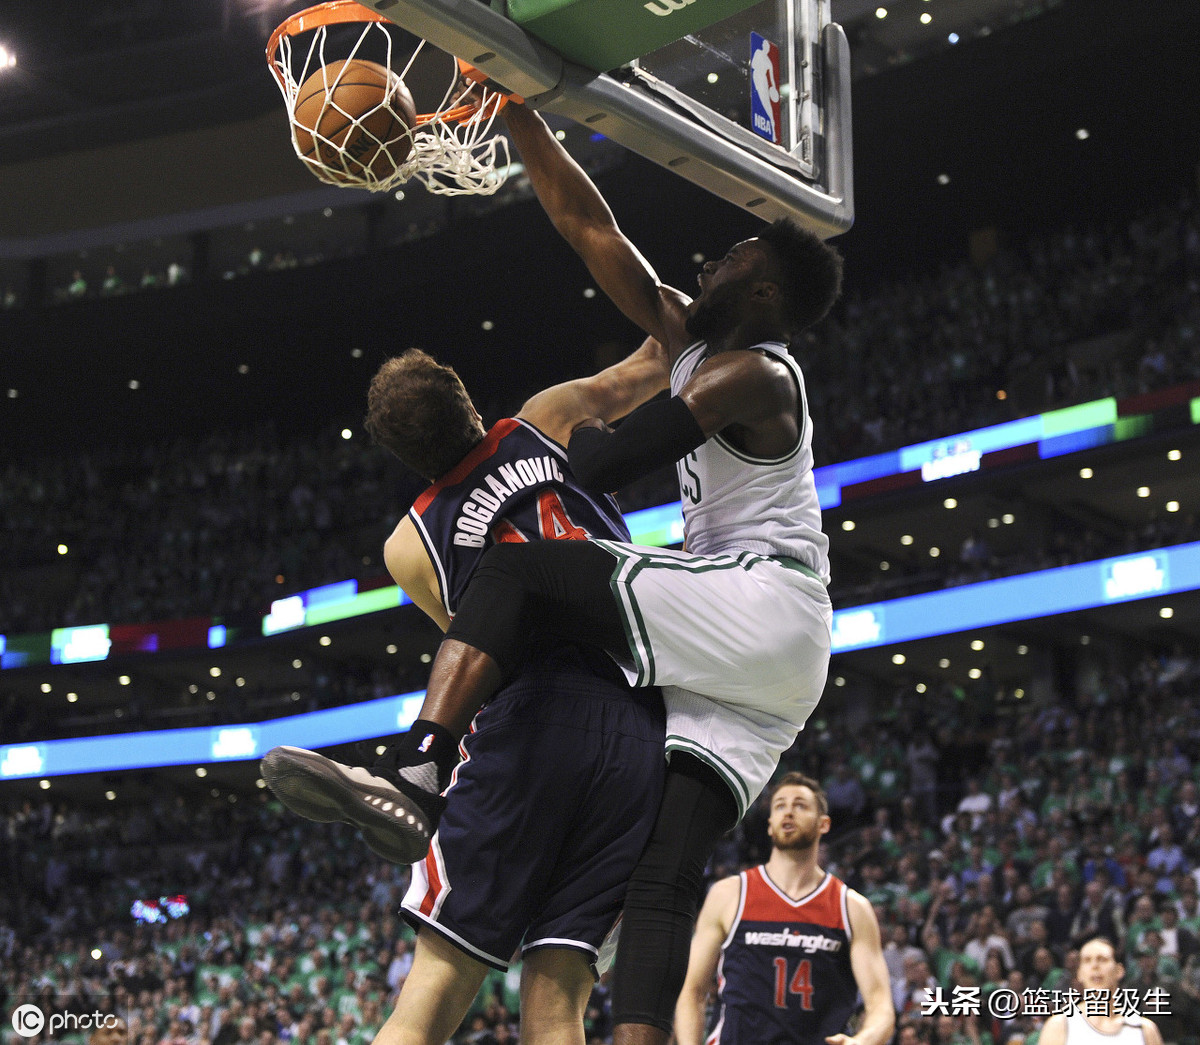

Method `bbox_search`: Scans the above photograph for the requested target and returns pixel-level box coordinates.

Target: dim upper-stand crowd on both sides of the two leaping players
[0,198,1200,633]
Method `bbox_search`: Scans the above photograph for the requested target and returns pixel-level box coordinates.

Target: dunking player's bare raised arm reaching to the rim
[504,102,690,360]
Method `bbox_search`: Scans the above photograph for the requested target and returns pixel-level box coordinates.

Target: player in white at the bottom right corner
[1038,936,1163,1045]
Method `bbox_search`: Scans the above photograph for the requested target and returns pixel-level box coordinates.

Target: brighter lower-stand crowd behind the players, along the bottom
[0,653,1200,1045]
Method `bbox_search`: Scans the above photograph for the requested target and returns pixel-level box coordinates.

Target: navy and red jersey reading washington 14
[708,865,858,1045]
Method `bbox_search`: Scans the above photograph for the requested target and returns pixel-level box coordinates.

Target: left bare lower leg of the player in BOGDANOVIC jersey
[373,930,487,1045]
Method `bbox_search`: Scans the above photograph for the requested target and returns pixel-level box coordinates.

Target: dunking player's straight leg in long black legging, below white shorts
[613,753,738,1045]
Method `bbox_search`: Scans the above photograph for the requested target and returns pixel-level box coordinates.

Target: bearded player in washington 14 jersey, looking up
[676,773,895,1045]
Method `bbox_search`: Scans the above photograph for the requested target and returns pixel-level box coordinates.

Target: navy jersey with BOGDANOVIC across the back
[408,418,629,617]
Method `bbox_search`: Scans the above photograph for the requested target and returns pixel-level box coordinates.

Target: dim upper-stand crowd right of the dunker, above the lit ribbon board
[802,190,1200,464]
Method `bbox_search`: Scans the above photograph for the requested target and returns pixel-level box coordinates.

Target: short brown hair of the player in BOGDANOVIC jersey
[365,348,485,480]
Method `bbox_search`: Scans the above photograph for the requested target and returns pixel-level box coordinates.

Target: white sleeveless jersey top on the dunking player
[671,341,829,583]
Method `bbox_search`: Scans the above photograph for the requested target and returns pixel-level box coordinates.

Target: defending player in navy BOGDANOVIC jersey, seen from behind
[263,342,666,1045]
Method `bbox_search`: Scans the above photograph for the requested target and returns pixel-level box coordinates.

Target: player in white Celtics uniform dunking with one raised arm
[266,103,841,1045]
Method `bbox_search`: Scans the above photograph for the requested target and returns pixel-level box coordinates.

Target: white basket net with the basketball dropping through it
[268,2,510,196]
